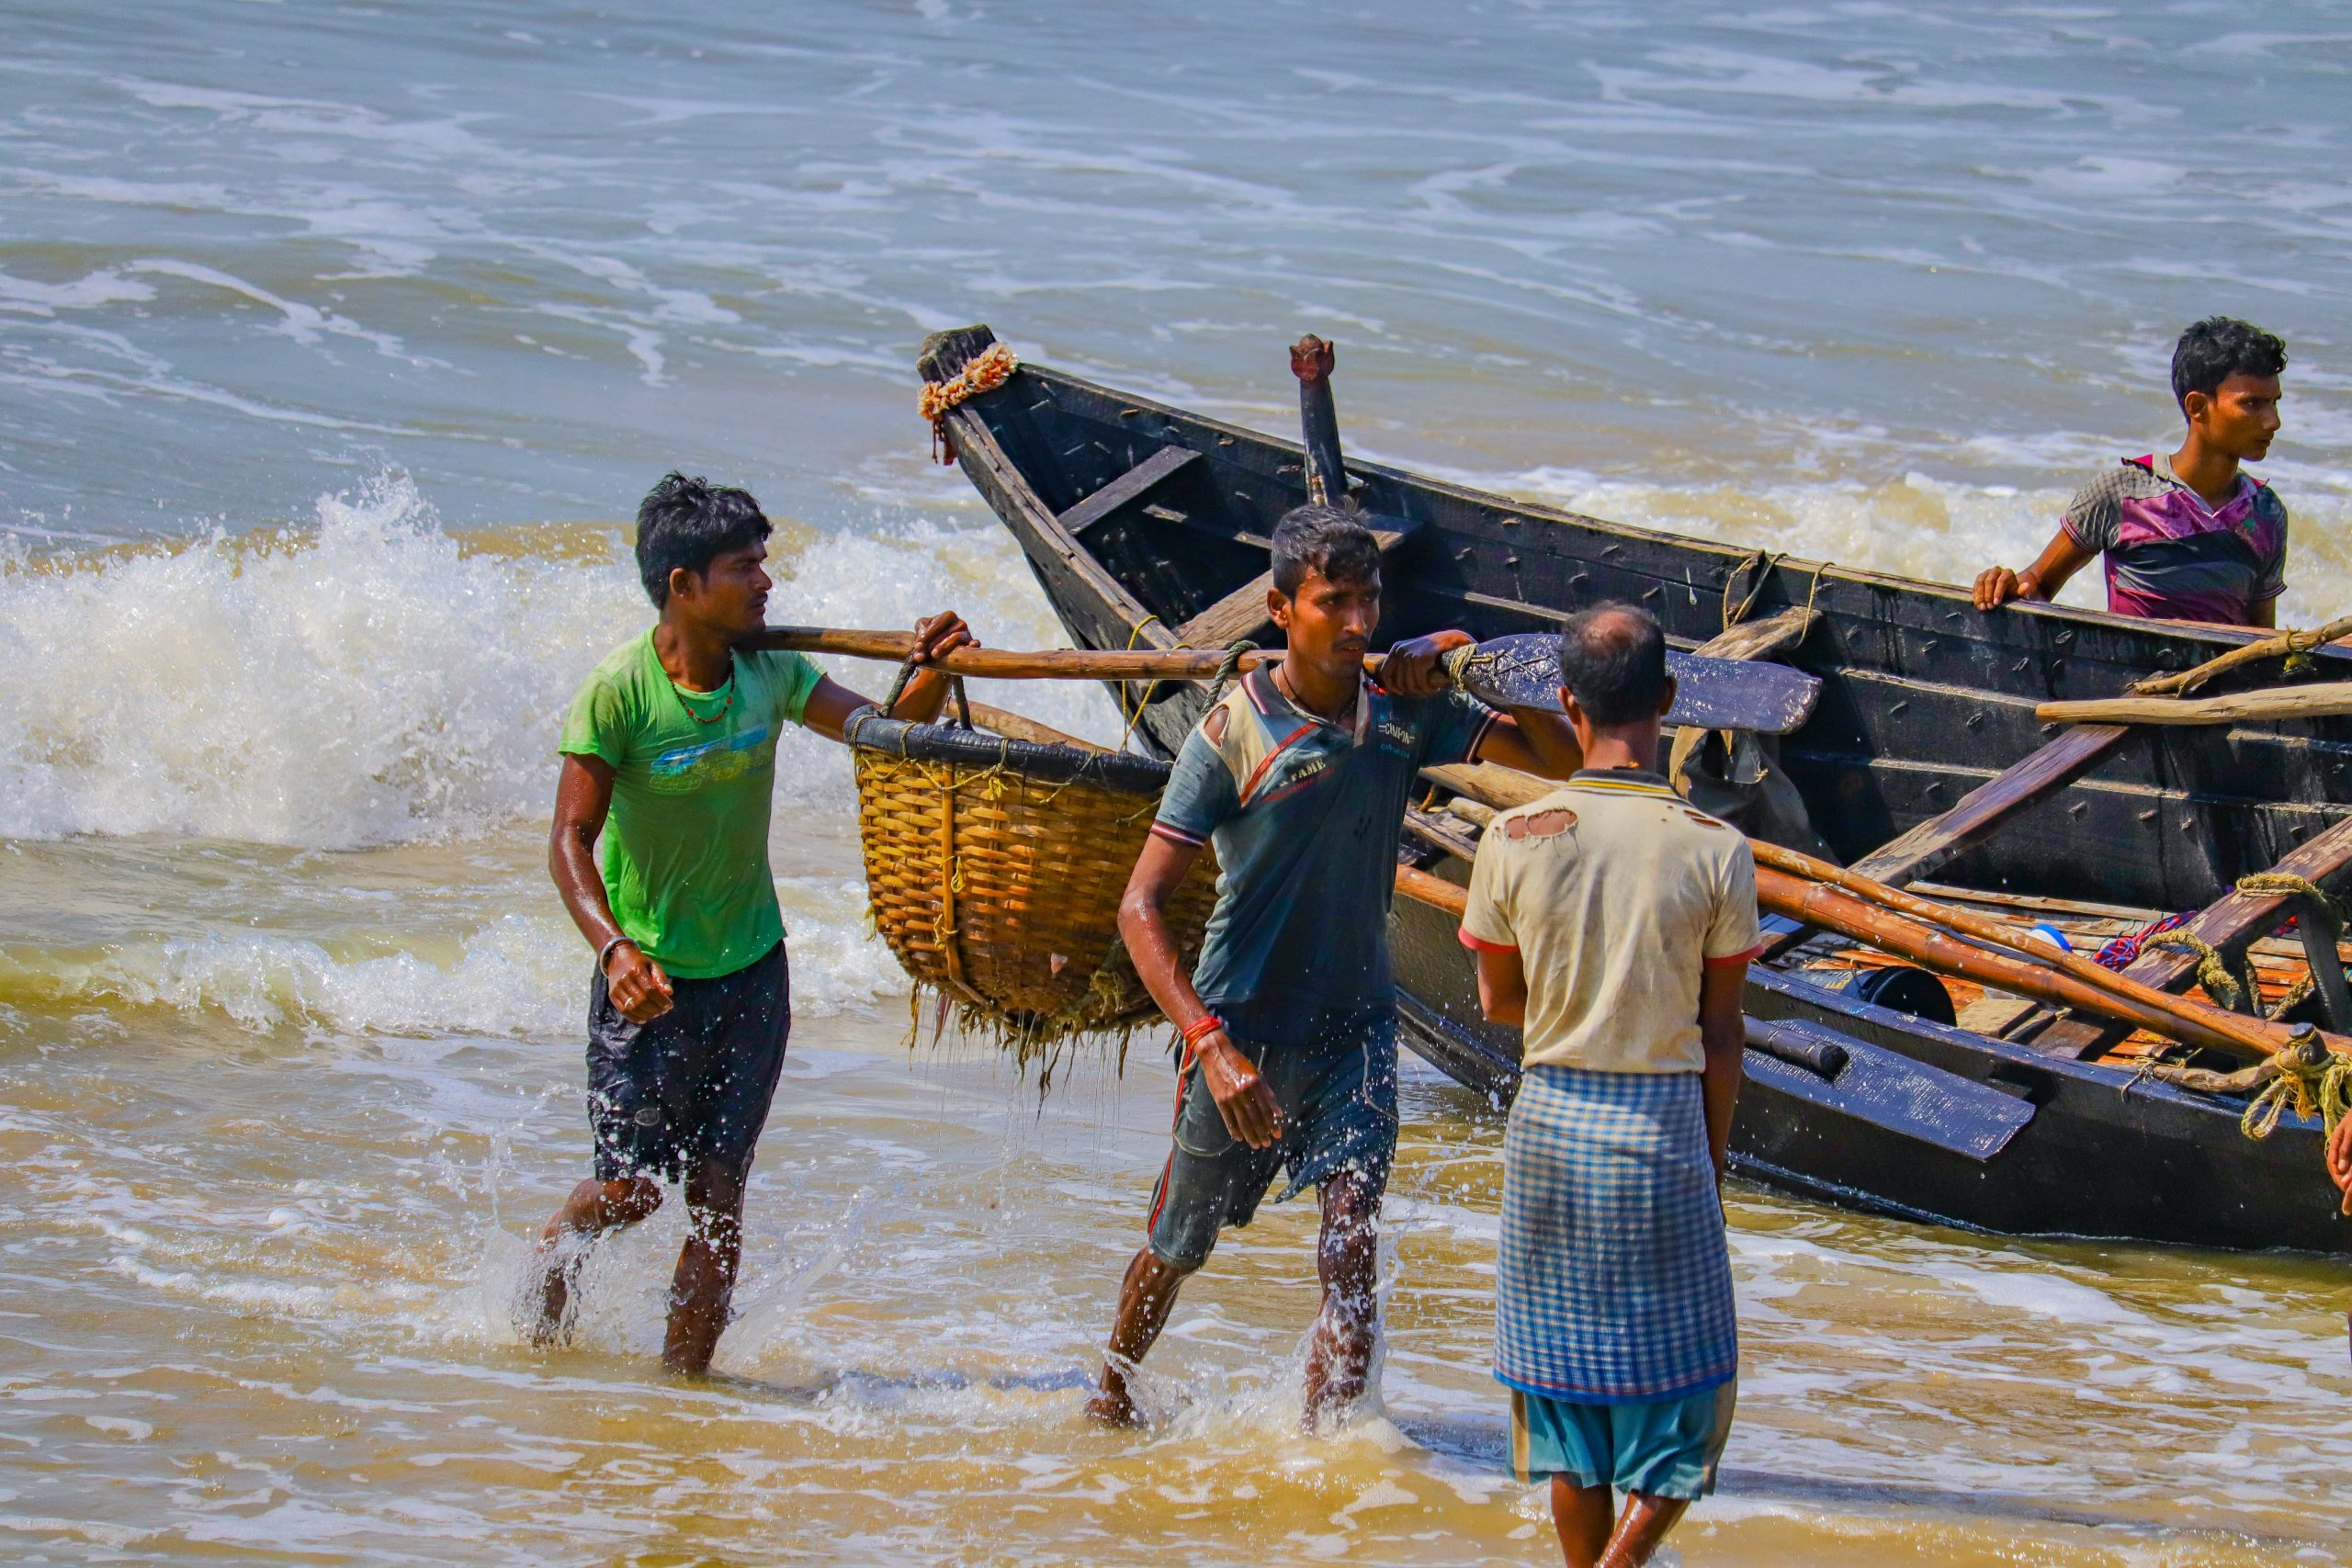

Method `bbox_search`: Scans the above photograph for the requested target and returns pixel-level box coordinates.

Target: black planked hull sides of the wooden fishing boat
[927,332,2352,1253]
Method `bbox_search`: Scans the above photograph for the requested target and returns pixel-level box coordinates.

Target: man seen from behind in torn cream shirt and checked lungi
[1461,604,1757,1568]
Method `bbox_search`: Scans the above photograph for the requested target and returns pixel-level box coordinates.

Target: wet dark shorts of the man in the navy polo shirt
[1150,1009,1397,1274]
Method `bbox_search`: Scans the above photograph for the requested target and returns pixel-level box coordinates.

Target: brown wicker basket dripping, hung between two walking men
[849,710,1216,1060]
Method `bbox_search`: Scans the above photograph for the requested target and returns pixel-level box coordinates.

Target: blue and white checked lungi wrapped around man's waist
[1494,1065,1740,1404]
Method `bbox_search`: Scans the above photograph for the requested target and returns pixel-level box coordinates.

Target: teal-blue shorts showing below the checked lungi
[1510,1380,1738,1502]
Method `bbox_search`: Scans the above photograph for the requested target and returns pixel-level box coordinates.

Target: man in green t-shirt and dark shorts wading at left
[522,472,974,1373]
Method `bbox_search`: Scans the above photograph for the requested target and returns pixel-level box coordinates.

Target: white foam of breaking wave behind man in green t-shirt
[0,478,1114,849]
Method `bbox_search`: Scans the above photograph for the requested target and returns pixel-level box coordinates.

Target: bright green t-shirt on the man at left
[558,627,819,980]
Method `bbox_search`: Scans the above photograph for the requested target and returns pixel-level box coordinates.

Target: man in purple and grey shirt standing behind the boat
[1975,315,2286,626]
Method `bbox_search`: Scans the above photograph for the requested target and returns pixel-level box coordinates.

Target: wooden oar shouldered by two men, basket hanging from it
[741,626,1820,736]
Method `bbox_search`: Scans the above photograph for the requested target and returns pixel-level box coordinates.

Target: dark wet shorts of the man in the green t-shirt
[588,942,793,1182]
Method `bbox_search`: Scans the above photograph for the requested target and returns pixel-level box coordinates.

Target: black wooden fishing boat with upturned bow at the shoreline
[920,327,2352,1253]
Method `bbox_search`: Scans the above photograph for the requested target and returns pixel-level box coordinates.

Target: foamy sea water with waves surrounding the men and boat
[0,0,2352,1568]
